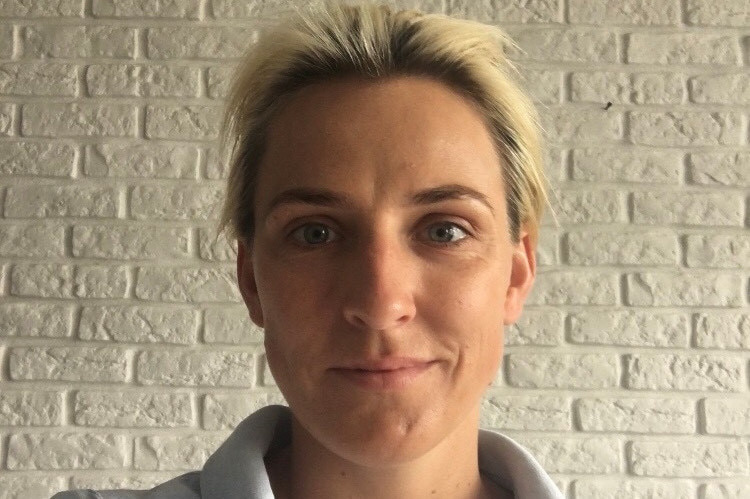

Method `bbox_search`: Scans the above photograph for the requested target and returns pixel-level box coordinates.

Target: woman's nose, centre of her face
[344,234,417,331]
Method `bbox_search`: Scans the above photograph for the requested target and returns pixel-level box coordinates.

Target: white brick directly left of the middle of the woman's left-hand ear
[135,266,239,303]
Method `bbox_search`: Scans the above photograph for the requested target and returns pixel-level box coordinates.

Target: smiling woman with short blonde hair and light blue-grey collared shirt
[55,5,562,499]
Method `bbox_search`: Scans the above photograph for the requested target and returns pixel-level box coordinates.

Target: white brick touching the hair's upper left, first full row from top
[146,26,254,60]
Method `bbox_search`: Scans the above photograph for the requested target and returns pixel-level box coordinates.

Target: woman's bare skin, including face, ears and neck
[237,77,535,498]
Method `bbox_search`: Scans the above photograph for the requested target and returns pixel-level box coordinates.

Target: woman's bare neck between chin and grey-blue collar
[266,410,505,499]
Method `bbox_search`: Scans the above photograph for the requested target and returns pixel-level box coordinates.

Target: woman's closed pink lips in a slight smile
[330,357,436,391]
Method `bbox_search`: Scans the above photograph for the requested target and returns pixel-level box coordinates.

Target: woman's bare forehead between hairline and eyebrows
[256,77,502,207]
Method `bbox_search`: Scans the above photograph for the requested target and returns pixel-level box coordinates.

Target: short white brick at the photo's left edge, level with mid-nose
[10,263,73,298]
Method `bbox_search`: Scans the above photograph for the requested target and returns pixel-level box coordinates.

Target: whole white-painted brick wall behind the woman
[0,0,750,499]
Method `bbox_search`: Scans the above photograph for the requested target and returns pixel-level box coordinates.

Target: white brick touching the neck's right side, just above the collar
[480,393,573,431]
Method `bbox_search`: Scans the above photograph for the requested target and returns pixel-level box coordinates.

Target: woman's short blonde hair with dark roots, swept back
[219,3,547,243]
